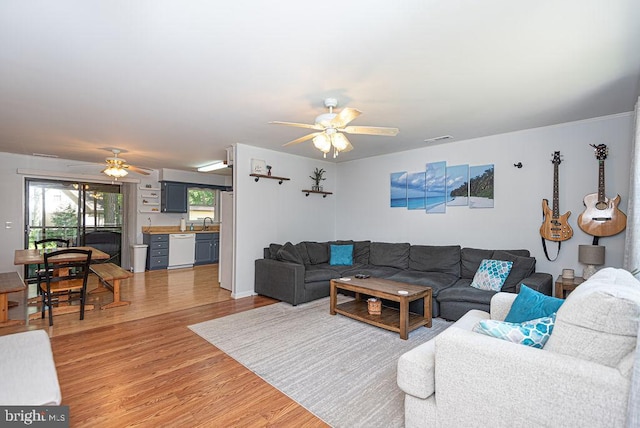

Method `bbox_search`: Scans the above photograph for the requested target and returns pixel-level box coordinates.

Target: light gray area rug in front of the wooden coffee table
[189,296,451,428]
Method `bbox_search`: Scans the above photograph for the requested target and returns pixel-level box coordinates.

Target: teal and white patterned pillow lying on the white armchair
[473,313,556,349]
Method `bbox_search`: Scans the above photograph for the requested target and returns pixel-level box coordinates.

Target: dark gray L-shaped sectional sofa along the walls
[255,241,552,320]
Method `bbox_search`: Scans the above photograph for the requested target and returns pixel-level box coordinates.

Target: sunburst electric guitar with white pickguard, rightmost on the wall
[578,144,627,237]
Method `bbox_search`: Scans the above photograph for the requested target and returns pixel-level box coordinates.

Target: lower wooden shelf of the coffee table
[336,300,430,333]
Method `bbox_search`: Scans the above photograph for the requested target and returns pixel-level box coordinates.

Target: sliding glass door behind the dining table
[25,179,123,278]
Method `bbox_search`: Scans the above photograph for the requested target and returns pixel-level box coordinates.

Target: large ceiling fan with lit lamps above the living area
[269,98,398,158]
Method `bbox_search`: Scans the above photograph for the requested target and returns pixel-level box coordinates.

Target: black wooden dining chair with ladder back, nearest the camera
[38,248,91,326]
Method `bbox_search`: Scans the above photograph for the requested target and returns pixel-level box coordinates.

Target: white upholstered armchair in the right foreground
[398,268,640,428]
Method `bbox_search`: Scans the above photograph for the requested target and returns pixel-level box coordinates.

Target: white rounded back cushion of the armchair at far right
[544,268,640,376]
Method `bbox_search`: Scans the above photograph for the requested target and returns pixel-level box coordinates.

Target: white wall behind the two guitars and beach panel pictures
[335,113,633,277]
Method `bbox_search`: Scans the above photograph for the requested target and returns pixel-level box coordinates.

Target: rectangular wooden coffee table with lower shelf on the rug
[329,277,431,340]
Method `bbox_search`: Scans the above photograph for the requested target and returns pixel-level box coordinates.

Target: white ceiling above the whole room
[0,0,640,174]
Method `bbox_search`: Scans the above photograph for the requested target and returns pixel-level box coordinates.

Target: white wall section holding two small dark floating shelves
[233,144,336,298]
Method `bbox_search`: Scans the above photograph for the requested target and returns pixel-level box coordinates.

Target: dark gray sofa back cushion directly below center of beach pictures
[409,245,460,277]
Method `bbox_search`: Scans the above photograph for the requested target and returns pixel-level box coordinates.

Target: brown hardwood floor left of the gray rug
[0,265,327,428]
